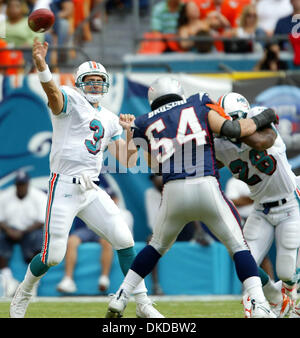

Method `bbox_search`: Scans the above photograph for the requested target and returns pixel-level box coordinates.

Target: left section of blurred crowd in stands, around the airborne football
[0,0,134,74]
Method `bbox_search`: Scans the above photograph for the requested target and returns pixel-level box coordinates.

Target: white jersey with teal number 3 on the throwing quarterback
[50,86,123,179]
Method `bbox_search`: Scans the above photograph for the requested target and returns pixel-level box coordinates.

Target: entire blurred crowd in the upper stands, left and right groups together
[0,0,300,74]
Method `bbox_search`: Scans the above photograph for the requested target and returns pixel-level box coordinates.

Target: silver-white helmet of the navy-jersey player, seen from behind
[148,76,185,106]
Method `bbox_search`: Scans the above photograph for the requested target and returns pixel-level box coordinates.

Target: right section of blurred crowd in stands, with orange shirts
[138,0,300,71]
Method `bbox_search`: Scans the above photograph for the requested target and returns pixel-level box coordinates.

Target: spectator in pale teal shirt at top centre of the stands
[151,0,182,34]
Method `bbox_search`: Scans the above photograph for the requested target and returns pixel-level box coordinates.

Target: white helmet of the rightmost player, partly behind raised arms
[218,92,250,120]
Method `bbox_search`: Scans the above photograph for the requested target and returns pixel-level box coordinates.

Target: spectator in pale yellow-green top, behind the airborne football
[6,0,44,63]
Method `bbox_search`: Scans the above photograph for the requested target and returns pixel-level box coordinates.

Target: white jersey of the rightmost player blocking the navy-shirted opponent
[215,109,296,203]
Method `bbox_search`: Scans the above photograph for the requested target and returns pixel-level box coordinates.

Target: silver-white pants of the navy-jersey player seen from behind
[149,176,249,255]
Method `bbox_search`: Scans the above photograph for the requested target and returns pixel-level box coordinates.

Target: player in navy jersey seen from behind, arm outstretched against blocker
[108,77,276,318]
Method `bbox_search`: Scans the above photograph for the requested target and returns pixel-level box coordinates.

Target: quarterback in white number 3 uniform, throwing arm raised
[10,40,163,318]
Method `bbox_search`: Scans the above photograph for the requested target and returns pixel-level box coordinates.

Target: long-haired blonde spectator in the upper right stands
[224,5,266,53]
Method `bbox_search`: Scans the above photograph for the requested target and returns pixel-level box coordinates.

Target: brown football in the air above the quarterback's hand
[28,8,55,33]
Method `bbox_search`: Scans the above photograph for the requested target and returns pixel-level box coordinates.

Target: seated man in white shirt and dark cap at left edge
[0,172,47,297]
